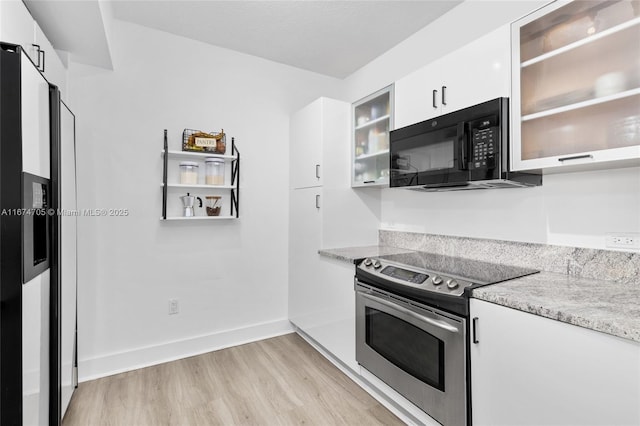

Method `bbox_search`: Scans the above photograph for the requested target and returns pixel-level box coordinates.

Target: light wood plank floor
[62,333,403,426]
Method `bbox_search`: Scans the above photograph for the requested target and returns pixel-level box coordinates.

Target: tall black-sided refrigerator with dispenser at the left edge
[0,43,78,426]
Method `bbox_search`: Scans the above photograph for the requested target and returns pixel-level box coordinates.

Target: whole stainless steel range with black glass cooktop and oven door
[355,252,537,426]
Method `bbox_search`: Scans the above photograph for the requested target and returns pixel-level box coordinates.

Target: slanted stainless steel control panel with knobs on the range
[358,258,473,296]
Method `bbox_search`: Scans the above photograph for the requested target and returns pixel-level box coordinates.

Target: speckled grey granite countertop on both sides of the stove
[318,246,640,343]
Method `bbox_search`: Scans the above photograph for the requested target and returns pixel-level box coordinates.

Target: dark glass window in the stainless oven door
[365,306,444,392]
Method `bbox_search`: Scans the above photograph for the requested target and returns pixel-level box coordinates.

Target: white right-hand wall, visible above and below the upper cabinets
[345,0,640,248]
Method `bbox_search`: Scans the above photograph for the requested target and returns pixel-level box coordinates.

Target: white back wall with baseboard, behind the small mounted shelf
[70,21,341,381]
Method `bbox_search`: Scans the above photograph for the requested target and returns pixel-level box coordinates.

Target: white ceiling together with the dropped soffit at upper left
[22,0,461,78]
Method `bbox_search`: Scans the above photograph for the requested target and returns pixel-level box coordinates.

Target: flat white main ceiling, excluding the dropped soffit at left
[112,0,460,78]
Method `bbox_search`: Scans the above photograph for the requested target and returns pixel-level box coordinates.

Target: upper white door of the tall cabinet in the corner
[289,98,323,189]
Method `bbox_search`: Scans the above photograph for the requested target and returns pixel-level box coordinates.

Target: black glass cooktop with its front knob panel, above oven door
[356,251,539,313]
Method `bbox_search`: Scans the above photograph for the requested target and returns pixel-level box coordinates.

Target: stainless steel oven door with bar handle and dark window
[356,284,467,425]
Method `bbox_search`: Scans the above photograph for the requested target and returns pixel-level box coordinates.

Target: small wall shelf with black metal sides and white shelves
[160,129,240,221]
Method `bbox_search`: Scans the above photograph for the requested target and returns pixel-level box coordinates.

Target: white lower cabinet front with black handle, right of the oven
[471,299,640,426]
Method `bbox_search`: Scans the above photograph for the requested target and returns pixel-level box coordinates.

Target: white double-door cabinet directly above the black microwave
[395,25,510,129]
